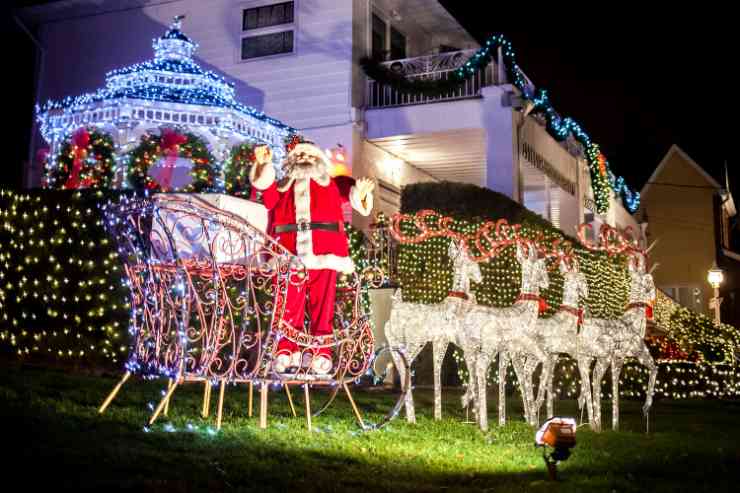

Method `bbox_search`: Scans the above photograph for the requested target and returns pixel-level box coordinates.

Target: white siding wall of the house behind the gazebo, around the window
[41,0,352,131]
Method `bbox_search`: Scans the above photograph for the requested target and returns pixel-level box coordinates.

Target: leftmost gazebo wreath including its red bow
[46,127,114,189]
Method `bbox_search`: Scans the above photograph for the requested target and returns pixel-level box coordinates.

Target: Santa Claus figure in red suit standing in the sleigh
[249,143,375,374]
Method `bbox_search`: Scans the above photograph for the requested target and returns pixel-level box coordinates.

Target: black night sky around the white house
[0,0,740,191]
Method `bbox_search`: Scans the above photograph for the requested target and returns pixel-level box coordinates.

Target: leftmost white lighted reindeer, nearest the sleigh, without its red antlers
[385,236,482,423]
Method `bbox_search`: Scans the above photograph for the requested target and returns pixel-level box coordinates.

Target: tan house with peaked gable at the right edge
[638,145,740,321]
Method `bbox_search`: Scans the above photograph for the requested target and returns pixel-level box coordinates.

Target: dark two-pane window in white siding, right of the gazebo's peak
[240,1,295,60]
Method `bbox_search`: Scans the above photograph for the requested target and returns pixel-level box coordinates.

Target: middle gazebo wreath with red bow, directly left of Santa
[128,128,218,192]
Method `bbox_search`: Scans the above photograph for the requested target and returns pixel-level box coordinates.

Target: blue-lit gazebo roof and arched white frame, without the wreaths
[37,16,296,187]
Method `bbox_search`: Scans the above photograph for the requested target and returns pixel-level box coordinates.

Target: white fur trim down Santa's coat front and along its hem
[293,178,355,274]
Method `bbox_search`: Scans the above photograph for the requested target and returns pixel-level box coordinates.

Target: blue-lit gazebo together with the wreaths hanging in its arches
[36,16,295,190]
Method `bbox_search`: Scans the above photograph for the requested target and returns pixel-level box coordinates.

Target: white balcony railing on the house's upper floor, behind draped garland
[366,50,503,108]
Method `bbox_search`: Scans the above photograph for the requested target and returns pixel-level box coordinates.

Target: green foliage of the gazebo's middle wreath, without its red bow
[128,132,219,192]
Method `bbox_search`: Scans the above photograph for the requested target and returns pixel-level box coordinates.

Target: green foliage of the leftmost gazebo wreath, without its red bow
[47,127,114,189]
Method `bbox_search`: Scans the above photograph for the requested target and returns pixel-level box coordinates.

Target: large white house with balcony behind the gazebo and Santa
[18,0,641,238]
